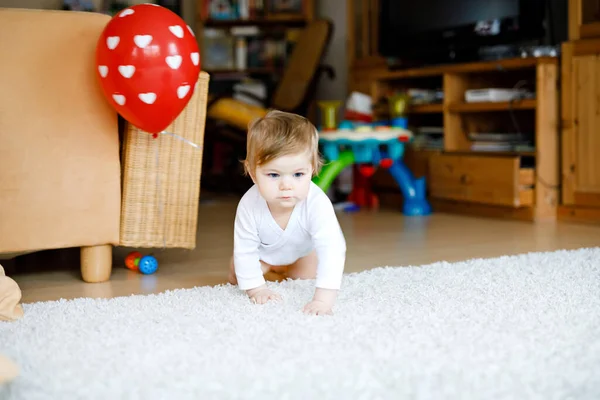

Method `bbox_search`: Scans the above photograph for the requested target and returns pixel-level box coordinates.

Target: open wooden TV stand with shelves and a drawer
[371,57,559,221]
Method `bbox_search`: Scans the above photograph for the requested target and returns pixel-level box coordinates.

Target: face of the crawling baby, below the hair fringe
[254,152,312,209]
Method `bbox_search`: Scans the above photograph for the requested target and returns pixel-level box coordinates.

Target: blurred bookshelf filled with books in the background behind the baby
[196,0,315,76]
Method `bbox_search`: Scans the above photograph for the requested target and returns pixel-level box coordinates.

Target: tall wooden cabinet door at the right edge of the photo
[560,39,600,221]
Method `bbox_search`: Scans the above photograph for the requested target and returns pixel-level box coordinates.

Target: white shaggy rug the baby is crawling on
[0,248,600,400]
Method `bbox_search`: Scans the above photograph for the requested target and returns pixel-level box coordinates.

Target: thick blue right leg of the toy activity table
[389,161,431,216]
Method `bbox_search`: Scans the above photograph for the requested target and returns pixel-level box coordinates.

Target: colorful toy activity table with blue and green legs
[313,124,431,216]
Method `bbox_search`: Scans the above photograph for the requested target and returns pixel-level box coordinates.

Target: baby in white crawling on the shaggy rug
[229,111,346,315]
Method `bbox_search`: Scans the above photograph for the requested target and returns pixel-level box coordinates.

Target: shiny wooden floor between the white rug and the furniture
[8,196,600,303]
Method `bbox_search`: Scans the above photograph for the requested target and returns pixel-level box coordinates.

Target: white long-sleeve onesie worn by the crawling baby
[233,182,346,290]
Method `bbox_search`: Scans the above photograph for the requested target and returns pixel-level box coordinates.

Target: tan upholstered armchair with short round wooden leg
[0,9,208,282]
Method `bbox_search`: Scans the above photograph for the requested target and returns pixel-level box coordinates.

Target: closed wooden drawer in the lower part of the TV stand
[429,154,534,207]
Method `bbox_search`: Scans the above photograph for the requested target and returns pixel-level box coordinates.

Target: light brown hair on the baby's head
[244,110,323,176]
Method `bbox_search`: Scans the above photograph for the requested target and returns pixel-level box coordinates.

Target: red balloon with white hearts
[96,4,200,134]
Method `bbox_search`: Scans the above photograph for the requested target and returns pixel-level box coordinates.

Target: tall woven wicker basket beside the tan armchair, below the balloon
[120,72,209,249]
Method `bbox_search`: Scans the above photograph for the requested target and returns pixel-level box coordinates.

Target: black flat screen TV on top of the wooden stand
[378,0,567,64]
